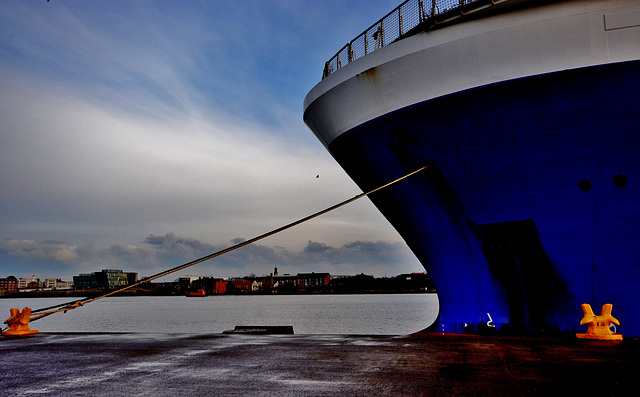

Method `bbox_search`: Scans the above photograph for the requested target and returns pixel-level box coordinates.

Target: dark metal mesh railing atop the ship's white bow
[322,0,506,79]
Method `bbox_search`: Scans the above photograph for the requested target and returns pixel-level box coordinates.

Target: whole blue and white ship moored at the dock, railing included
[304,0,640,337]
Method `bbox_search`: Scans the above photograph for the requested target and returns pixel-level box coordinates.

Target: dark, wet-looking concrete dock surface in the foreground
[0,333,640,396]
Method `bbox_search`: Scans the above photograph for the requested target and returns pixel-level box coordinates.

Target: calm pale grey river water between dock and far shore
[0,294,438,335]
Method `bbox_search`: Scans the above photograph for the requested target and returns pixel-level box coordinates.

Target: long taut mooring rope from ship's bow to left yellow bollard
[22,165,429,321]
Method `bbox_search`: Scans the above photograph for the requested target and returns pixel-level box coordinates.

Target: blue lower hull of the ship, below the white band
[328,61,640,336]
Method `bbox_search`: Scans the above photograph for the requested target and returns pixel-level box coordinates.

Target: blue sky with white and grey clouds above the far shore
[0,0,422,280]
